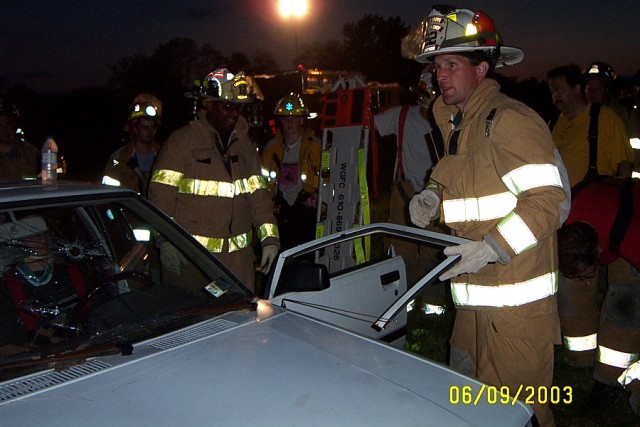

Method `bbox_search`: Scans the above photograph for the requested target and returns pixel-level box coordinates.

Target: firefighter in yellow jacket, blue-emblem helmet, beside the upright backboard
[262,93,321,250]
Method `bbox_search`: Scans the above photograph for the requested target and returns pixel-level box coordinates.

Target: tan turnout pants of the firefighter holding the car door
[449,297,560,427]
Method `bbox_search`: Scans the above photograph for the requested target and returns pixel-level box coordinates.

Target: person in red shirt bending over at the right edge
[558,176,640,411]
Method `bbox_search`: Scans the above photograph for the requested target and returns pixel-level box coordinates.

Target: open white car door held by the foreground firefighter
[267,223,465,342]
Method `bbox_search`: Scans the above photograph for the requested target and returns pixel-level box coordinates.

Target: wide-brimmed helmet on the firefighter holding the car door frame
[402,6,524,67]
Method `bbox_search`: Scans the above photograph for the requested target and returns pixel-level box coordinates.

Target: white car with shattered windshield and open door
[0,181,533,427]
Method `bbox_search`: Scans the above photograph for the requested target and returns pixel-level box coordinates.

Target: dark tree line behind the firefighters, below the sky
[0,14,636,180]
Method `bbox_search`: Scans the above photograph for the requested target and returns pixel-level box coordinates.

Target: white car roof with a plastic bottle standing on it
[0,180,135,203]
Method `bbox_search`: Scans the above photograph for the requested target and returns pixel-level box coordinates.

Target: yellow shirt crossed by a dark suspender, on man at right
[553,103,634,187]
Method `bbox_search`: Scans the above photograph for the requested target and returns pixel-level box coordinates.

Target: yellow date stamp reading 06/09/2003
[449,384,573,406]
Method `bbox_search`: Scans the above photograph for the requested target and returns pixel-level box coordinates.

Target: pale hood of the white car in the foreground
[0,305,532,427]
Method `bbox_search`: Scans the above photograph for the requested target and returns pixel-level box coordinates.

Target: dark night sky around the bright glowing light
[0,0,640,91]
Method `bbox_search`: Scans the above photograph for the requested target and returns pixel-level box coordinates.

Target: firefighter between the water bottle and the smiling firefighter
[102,93,162,197]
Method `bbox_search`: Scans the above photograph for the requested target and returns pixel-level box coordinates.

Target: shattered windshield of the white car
[0,197,251,370]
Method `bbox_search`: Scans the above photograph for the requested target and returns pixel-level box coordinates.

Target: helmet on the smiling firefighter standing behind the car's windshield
[195,68,253,103]
